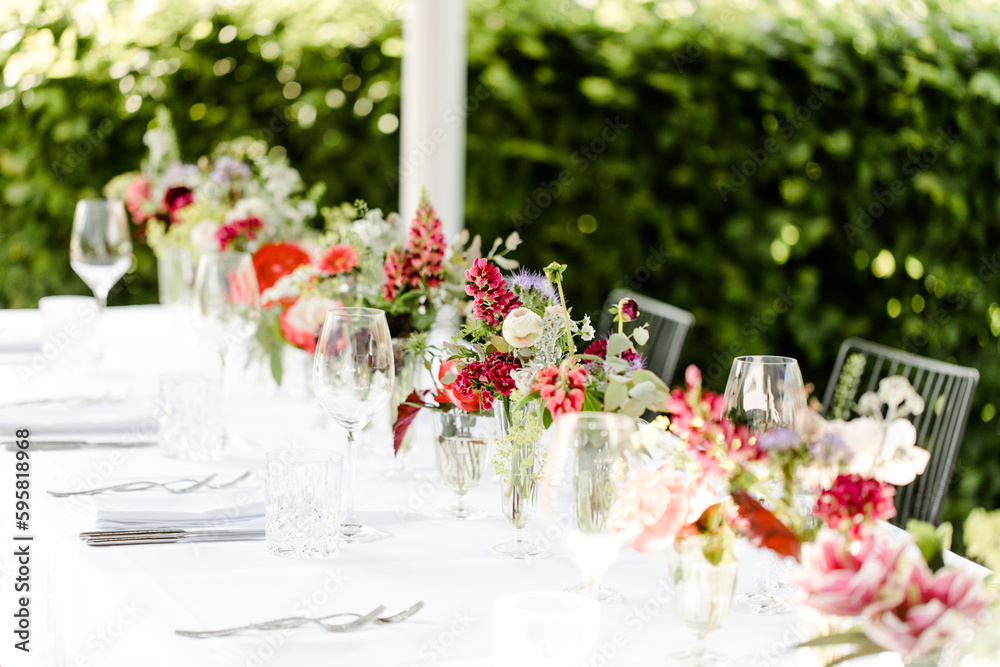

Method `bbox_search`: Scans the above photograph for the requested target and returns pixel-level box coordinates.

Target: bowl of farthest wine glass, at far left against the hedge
[69,199,132,312]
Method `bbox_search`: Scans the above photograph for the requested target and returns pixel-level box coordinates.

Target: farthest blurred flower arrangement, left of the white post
[105,109,323,254]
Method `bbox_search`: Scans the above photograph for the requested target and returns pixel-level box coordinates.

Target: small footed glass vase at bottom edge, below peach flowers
[667,536,739,666]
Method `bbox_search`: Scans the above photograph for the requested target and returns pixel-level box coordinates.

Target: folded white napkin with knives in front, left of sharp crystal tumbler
[94,486,264,530]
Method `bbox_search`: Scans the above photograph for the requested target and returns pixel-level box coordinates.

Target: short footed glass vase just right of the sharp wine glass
[434,409,495,521]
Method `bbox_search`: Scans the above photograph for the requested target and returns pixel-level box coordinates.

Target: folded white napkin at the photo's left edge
[0,398,157,440]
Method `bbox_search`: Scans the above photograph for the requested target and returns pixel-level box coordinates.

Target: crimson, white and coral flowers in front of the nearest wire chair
[659,367,929,558]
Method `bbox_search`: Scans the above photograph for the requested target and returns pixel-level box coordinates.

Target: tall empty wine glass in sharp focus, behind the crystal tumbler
[313,308,395,543]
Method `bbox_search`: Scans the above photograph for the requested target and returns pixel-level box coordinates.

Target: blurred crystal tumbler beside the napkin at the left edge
[159,374,225,461]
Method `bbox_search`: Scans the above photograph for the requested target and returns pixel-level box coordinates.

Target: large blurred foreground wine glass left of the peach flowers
[542,412,638,603]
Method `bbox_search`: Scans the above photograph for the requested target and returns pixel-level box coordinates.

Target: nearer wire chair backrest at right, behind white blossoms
[823,338,979,526]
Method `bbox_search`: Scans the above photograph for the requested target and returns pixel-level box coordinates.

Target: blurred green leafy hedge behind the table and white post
[0,0,1000,548]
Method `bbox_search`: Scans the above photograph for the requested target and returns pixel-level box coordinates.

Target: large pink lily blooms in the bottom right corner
[797,521,989,664]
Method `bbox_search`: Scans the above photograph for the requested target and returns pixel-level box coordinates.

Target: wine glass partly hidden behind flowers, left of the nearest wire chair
[722,356,806,615]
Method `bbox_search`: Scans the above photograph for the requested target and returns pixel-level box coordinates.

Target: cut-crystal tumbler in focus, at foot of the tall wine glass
[264,449,344,558]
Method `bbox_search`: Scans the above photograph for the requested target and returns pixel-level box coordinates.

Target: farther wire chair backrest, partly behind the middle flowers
[597,290,694,385]
